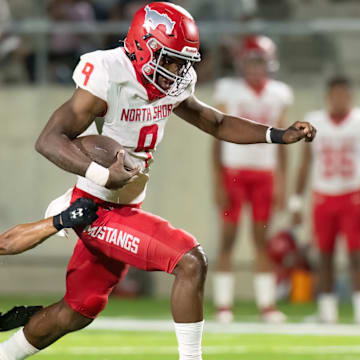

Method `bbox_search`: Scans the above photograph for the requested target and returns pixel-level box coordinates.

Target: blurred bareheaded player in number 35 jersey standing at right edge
[289,76,360,323]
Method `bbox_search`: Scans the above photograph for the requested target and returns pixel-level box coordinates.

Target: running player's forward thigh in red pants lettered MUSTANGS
[79,206,199,273]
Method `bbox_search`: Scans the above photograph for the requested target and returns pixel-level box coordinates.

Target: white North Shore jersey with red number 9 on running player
[73,47,196,204]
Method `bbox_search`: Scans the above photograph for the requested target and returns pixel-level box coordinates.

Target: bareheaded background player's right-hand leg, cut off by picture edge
[341,192,360,324]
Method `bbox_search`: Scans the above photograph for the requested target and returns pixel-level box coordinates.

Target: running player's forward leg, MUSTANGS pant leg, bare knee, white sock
[81,202,207,360]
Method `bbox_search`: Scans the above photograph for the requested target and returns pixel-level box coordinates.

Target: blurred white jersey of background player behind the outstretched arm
[214,78,293,170]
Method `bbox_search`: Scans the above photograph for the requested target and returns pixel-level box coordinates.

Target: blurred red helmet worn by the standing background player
[238,35,279,72]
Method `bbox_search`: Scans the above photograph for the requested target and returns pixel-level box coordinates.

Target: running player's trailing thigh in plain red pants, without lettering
[64,240,128,318]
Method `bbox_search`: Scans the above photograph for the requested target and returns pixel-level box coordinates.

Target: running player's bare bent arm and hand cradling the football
[35,89,139,188]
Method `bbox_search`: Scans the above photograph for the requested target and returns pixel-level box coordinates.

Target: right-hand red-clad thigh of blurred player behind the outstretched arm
[249,171,274,224]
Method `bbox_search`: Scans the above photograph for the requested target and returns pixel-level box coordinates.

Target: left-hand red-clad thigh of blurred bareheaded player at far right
[312,202,340,253]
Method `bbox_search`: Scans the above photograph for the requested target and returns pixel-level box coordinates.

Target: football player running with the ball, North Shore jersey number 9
[0,2,316,360]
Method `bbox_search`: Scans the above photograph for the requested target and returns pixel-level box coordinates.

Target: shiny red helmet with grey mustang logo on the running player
[125,2,200,97]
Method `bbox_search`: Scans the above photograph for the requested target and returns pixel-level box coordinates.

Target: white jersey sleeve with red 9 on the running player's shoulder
[73,51,109,101]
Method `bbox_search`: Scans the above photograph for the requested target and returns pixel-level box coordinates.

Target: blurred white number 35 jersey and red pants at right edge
[305,108,360,252]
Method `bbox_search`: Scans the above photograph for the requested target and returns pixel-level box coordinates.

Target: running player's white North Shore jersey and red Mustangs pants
[50,48,198,318]
